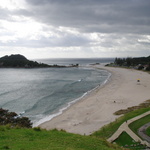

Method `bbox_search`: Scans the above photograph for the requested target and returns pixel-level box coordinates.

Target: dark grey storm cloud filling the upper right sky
[26,0,150,34]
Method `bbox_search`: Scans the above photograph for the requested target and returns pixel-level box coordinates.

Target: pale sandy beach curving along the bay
[39,65,150,135]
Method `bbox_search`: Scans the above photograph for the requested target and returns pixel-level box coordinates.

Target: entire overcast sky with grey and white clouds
[0,0,150,58]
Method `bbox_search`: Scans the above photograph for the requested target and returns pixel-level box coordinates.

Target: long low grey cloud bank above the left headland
[0,34,92,48]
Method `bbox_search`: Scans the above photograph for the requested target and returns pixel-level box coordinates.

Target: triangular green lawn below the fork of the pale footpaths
[114,132,145,149]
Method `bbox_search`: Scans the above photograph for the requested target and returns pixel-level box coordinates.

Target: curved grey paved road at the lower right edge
[138,122,150,143]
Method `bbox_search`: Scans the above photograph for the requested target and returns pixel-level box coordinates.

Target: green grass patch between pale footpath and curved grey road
[129,115,150,135]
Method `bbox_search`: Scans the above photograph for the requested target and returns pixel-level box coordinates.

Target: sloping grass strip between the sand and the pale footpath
[92,107,150,139]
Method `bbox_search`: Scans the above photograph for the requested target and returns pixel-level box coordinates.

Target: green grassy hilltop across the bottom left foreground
[0,126,121,150]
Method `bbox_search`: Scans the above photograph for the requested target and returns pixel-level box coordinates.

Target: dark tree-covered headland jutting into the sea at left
[0,54,78,68]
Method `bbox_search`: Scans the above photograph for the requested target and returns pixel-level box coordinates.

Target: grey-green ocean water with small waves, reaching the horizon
[0,59,114,126]
